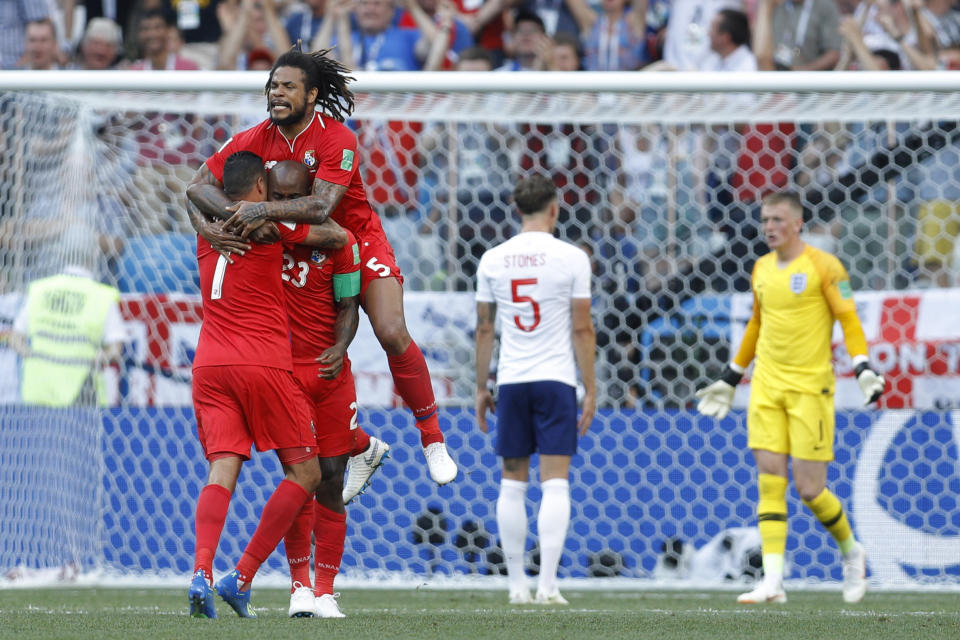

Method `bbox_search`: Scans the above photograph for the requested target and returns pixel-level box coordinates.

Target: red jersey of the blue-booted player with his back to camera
[193,223,310,371]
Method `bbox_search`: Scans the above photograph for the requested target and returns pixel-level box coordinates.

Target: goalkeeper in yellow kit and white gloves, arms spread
[696,192,884,604]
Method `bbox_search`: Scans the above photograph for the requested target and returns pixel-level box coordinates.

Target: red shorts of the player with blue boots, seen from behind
[193,365,317,464]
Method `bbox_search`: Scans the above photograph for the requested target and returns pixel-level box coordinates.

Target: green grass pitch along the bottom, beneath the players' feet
[0,584,960,640]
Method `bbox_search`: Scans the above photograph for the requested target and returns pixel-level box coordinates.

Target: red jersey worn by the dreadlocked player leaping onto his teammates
[207,112,383,239]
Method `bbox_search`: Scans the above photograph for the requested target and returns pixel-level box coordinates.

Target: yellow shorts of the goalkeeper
[747,383,834,462]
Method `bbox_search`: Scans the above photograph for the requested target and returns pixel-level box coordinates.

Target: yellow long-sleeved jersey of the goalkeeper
[734,245,867,394]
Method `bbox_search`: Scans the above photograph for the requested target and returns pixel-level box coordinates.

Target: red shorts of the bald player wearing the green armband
[293,358,357,458]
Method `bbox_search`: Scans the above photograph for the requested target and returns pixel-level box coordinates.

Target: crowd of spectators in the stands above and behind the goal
[0,0,960,406]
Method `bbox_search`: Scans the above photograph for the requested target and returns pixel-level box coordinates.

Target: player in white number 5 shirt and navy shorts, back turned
[476,175,596,604]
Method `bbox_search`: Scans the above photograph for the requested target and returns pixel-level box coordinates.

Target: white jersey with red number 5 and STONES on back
[477,231,591,386]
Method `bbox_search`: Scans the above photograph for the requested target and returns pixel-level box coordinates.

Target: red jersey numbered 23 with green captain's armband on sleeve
[283,231,360,364]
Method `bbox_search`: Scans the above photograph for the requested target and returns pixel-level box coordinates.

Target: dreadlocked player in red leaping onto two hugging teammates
[187,50,457,485]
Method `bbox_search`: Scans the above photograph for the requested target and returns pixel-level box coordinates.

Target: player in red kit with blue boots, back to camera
[188,152,340,618]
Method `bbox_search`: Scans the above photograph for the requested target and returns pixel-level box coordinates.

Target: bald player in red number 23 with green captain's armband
[267,160,385,618]
